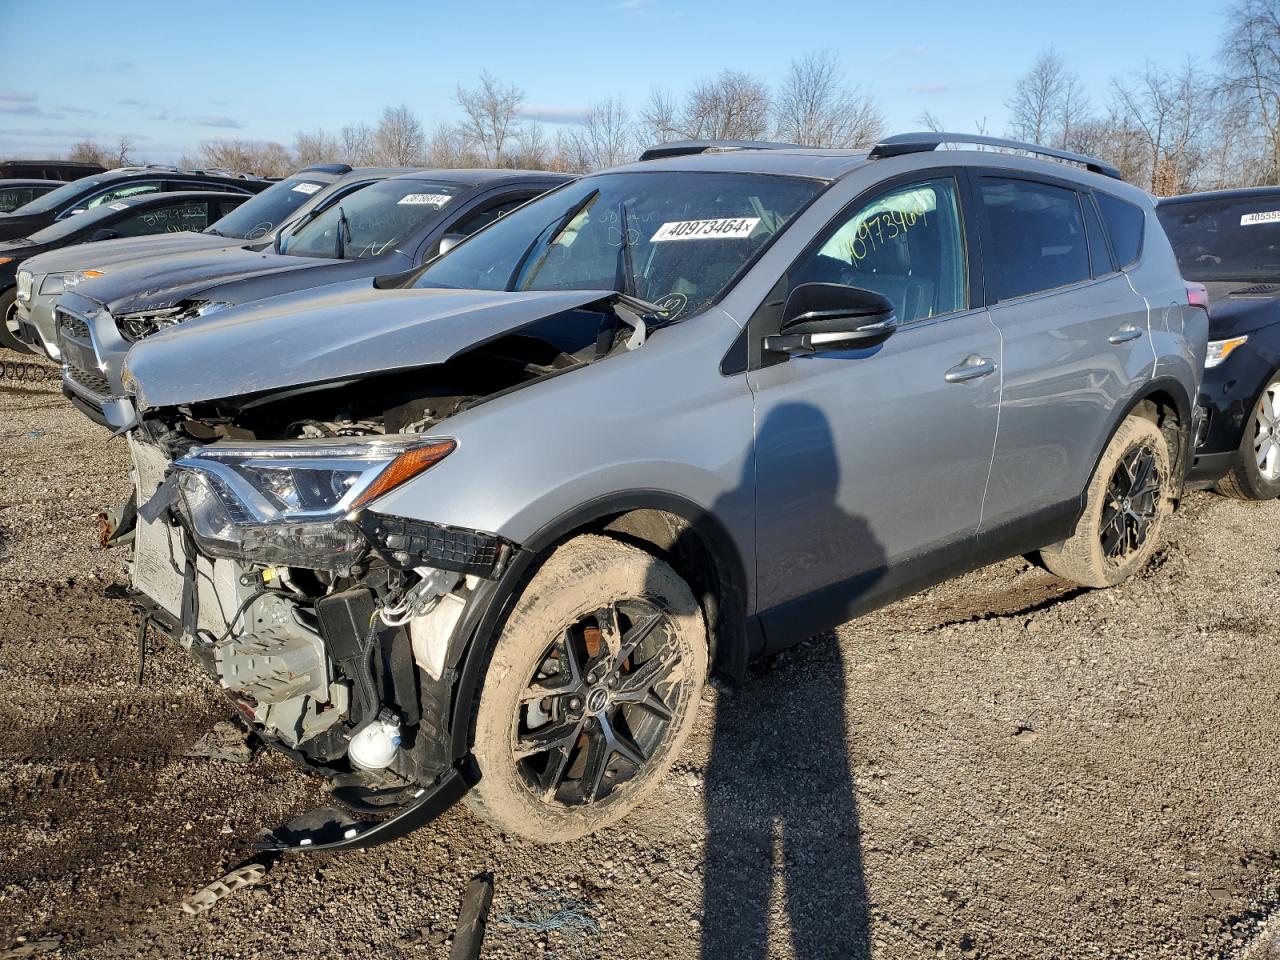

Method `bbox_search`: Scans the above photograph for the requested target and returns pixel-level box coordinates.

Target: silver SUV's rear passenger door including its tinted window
[972,170,1155,536]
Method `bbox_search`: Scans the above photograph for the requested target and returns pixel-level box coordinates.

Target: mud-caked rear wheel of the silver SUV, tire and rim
[1039,415,1174,588]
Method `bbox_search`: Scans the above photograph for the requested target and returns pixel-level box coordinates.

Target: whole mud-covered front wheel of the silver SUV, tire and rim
[467,536,707,842]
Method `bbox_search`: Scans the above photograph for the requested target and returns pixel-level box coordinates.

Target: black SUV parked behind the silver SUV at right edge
[1157,187,1280,499]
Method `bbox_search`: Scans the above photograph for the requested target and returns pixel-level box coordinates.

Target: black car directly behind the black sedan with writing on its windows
[0,165,271,241]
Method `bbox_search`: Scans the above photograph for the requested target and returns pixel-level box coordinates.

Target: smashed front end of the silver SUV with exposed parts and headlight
[115,288,644,850]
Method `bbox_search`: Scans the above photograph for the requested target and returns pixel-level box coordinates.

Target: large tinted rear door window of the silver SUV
[982,177,1091,301]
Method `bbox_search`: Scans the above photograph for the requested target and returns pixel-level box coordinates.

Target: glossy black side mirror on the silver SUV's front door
[764,283,897,353]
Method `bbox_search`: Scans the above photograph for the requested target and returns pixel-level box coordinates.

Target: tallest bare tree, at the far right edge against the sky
[1222,0,1280,183]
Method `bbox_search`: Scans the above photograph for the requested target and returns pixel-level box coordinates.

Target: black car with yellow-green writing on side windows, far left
[0,191,250,351]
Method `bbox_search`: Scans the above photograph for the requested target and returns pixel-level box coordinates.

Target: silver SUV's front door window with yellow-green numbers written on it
[787,177,969,324]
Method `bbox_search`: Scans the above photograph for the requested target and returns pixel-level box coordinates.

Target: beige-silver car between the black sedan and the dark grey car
[10,164,412,360]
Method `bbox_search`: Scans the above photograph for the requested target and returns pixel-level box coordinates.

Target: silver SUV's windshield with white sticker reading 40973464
[410,172,823,319]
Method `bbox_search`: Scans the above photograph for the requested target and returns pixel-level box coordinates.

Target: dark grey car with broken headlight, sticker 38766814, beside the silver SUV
[54,170,572,428]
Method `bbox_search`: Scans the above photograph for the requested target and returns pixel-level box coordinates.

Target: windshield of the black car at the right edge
[1156,196,1280,283]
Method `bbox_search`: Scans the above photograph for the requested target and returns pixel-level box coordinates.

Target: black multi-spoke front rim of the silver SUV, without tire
[512,599,686,806]
